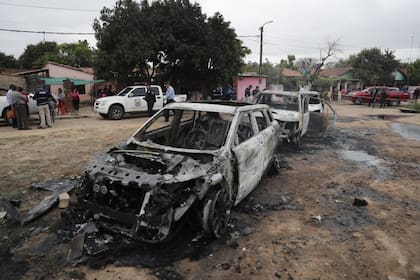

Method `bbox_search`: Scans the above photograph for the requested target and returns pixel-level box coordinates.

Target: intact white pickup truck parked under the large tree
[94,85,187,120]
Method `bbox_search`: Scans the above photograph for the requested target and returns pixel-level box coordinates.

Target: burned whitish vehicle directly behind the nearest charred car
[255,90,309,148]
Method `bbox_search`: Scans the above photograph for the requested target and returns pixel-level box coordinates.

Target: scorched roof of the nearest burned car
[165,100,270,115]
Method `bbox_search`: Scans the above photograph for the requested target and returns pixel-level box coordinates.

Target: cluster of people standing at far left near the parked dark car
[7,84,80,130]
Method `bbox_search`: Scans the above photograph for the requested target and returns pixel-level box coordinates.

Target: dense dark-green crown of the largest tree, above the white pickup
[93,0,249,88]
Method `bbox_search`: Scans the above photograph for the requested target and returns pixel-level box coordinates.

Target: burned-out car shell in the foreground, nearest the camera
[77,101,279,243]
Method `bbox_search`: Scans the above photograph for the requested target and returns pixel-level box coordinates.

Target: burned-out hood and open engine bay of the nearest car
[84,144,212,186]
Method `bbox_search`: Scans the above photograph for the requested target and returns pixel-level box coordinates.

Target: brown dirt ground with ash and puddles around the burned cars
[0,105,420,280]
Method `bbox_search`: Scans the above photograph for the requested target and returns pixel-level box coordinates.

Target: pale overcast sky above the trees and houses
[0,0,420,63]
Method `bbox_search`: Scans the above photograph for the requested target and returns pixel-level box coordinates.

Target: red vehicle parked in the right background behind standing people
[348,86,410,106]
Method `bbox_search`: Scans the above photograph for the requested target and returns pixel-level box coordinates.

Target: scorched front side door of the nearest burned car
[232,112,264,204]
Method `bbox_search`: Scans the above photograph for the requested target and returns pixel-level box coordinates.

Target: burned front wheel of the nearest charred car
[203,188,232,238]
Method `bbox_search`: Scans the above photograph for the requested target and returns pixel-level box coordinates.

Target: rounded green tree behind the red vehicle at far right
[349,48,399,85]
